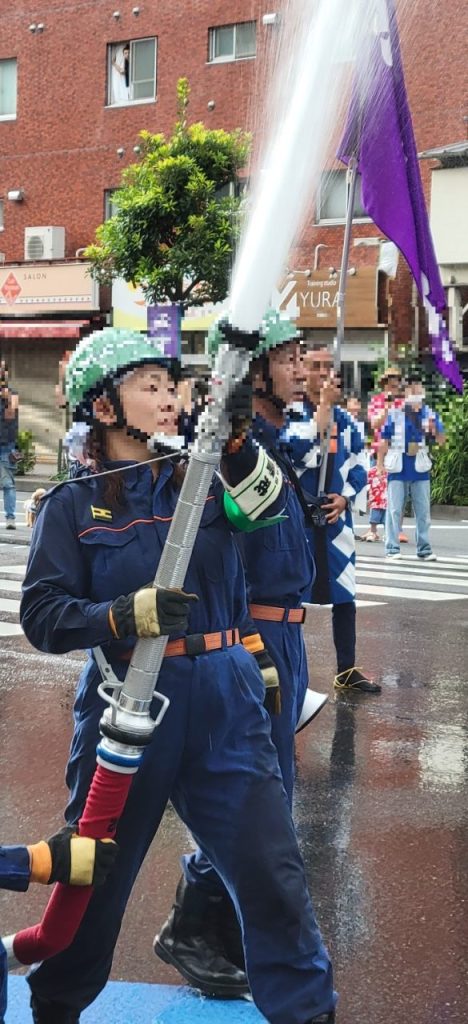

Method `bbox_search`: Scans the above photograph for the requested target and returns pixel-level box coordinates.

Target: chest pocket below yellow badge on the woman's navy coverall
[80,523,154,601]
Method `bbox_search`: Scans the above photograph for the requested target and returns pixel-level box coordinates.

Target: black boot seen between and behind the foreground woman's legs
[154,877,249,999]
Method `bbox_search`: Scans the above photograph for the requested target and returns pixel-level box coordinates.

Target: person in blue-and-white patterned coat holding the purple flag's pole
[287,345,381,693]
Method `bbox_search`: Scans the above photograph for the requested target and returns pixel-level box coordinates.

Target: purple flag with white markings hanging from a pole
[338,0,463,390]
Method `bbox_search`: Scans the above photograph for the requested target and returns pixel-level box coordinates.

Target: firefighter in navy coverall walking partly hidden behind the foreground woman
[155,310,327,997]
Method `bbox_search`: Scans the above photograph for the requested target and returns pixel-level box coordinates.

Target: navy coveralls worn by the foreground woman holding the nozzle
[22,463,335,1024]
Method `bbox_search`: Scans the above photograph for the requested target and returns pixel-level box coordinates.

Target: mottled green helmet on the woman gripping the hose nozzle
[65,328,170,412]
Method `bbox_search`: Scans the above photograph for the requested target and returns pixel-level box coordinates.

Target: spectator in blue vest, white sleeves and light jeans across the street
[377,377,445,562]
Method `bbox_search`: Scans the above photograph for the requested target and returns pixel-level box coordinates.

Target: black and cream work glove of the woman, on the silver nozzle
[109,586,198,640]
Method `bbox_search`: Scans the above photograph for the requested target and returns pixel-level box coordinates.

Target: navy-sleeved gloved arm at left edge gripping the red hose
[0,828,118,1024]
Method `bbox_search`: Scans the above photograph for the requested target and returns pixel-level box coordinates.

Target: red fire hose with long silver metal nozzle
[3,333,253,969]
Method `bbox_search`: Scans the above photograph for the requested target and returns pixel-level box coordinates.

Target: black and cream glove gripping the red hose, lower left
[28,827,119,886]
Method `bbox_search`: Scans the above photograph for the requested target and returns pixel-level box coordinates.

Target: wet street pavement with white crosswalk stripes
[0,516,468,1024]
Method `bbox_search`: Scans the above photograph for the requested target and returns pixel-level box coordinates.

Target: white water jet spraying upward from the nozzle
[227,0,376,330]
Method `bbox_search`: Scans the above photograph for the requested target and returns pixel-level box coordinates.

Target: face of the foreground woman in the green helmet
[119,364,182,436]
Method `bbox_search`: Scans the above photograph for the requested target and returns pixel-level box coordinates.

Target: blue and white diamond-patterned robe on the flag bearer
[283,406,368,604]
